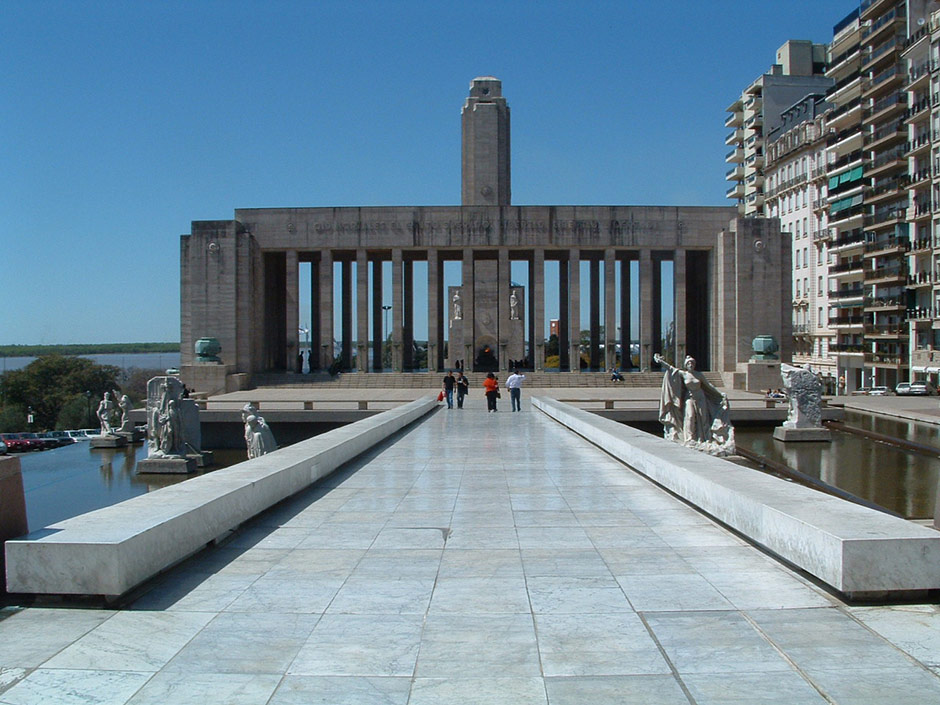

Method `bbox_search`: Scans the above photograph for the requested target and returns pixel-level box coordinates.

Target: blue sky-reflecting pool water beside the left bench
[19,441,245,531]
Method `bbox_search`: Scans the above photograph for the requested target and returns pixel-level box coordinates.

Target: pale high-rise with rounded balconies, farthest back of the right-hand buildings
[725,39,831,216]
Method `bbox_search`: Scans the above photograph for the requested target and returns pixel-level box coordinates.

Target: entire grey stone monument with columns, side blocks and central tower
[181,77,792,393]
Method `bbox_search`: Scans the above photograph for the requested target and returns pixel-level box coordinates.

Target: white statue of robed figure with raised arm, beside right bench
[653,353,734,456]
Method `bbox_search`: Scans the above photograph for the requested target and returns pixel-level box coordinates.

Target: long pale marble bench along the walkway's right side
[532,398,940,599]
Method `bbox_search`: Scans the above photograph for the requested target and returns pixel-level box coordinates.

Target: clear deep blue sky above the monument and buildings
[0,0,857,344]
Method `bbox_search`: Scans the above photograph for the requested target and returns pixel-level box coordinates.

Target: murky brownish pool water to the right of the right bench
[734,410,940,519]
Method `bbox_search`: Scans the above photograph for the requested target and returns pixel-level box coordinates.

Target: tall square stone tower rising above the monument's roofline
[460,76,510,206]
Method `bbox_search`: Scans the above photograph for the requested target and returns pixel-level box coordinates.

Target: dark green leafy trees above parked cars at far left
[0,355,120,428]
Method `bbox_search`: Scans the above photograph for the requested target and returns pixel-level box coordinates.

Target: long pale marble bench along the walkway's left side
[6,396,437,597]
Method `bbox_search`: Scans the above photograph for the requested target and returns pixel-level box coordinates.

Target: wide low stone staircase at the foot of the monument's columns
[253,371,724,389]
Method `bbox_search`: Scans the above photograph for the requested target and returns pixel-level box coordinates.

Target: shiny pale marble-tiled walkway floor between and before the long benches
[0,395,940,705]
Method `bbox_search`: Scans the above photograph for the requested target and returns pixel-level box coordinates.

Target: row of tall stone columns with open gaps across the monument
[276,247,688,372]
